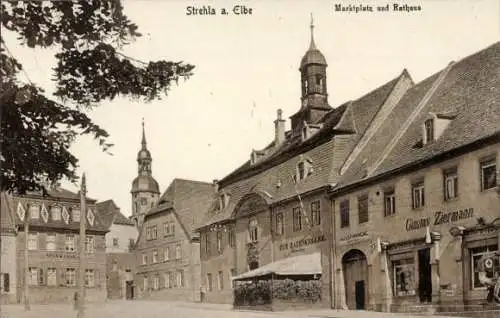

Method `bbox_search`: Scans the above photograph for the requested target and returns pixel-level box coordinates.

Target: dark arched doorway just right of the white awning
[342,249,368,310]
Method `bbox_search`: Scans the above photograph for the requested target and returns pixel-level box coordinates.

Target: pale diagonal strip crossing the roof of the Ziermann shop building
[367,62,455,175]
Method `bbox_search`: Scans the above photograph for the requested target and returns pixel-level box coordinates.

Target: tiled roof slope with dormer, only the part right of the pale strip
[373,42,500,175]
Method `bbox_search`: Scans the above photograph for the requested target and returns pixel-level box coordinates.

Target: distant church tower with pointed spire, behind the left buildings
[130,119,160,228]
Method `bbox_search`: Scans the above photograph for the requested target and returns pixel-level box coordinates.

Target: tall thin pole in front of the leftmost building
[77,173,87,318]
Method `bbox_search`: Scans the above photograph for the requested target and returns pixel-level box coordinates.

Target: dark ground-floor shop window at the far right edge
[470,244,500,289]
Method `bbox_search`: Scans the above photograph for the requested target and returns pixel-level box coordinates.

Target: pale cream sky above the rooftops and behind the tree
[5,0,500,216]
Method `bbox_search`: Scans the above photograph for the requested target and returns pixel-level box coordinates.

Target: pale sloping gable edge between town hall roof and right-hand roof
[340,69,414,175]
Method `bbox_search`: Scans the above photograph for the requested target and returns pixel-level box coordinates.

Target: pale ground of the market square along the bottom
[0,300,500,318]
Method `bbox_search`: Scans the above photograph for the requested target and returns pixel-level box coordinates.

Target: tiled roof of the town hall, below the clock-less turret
[198,77,399,226]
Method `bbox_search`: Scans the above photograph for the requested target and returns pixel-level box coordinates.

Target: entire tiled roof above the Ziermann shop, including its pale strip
[335,42,500,192]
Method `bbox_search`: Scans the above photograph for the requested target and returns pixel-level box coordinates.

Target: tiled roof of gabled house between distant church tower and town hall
[145,178,214,237]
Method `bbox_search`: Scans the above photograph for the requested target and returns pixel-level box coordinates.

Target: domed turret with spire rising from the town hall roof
[291,15,331,133]
